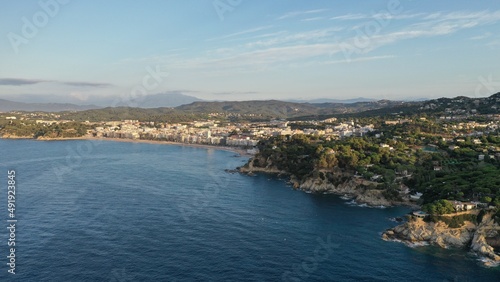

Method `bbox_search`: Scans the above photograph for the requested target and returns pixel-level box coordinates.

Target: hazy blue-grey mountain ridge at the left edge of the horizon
[0,99,100,112]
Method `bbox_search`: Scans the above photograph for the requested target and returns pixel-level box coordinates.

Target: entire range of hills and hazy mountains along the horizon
[0,93,500,120]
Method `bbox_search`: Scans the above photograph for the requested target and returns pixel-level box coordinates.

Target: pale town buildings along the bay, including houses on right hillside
[0,109,500,156]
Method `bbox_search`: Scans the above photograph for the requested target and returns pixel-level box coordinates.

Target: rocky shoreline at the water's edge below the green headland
[239,161,500,267]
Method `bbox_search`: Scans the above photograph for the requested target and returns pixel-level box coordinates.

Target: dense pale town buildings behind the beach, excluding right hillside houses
[0,112,375,154]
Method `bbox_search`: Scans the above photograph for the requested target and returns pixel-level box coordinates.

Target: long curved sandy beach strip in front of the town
[0,136,252,157]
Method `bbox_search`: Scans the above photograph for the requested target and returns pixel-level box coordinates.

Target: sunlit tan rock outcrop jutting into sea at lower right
[382,214,500,266]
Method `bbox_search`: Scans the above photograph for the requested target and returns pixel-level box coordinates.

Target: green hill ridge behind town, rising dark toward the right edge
[19,93,500,122]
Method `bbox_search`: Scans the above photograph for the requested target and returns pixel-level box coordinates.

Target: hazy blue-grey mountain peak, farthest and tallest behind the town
[117,93,202,108]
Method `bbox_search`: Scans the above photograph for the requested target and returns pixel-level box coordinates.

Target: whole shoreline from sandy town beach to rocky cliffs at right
[0,136,500,267]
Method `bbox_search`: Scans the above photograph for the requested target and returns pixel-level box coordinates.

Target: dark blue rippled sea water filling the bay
[0,140,500,282]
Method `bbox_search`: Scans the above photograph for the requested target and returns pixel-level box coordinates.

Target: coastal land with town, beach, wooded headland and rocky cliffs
[0,95,500,265]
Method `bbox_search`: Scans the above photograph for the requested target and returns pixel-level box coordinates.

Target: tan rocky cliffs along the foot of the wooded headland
[239,157,500,266]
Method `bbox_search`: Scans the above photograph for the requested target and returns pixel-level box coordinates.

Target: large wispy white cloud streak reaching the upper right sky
[127,12,500,75]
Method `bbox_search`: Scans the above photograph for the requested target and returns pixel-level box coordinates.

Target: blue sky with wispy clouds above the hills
[0,0,500,103]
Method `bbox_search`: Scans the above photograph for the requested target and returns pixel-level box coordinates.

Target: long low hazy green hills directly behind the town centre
[57,100,406,122]
